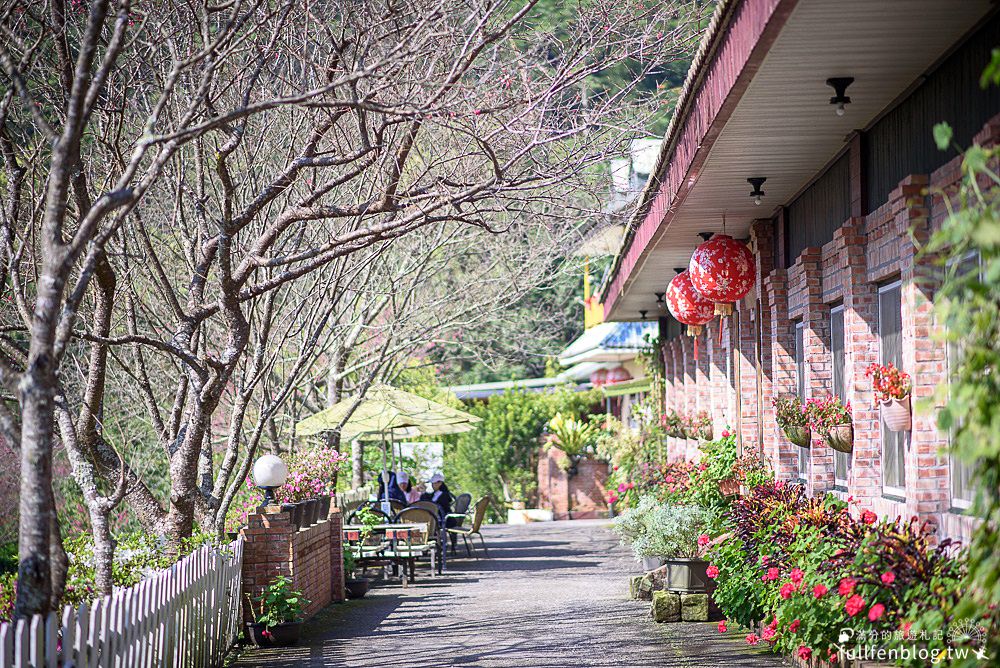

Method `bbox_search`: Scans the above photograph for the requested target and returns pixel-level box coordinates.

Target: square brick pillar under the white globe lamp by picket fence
[240,506,295,622]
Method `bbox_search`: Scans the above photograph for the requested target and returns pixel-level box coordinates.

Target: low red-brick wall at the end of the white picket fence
[240,506,344,621]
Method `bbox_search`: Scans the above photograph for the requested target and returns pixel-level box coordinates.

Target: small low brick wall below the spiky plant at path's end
[538,448,608,520]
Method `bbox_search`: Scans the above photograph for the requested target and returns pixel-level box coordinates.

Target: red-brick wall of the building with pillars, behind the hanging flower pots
[652,115,1000,539]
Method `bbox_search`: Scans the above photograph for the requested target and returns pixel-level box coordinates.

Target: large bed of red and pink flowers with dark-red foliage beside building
[708,482,984,665]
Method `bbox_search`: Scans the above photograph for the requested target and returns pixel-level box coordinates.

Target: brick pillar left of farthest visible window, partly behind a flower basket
[763,269,799,480]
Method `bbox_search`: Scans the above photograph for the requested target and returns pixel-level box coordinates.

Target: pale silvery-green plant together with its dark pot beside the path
[614,496,713,593]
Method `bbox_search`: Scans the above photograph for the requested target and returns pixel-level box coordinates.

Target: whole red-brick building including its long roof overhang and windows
[602,0,1000,537]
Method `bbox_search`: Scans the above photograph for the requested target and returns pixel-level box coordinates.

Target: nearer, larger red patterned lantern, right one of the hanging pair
[688,234,757,315]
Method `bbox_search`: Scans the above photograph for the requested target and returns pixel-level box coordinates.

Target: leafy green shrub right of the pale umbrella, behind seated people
[445,388,599,518]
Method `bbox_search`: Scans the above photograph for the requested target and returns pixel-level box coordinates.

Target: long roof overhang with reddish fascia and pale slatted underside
[602,0,992,321]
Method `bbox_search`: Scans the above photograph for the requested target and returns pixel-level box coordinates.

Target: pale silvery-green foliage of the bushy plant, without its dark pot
[614,496,711,559]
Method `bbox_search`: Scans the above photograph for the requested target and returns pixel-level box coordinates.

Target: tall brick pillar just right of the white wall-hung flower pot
[893,176,951,525]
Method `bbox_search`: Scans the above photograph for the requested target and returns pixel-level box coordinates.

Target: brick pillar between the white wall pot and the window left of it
[841,218,882,505]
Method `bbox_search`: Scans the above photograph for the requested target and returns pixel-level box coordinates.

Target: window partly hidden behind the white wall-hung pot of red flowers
[878,281,909,497]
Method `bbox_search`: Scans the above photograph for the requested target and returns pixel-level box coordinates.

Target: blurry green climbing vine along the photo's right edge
[918,109,1000,657]
